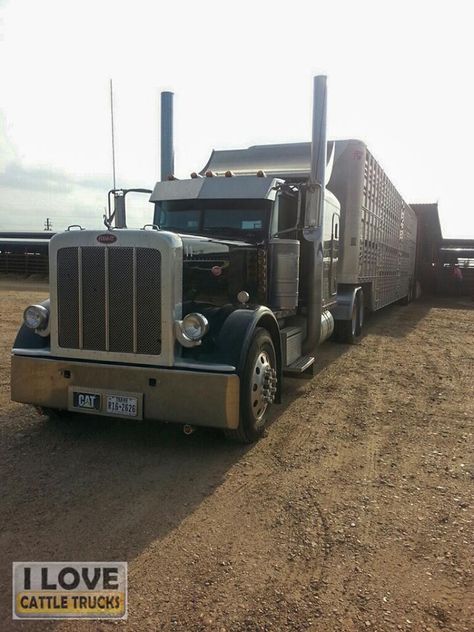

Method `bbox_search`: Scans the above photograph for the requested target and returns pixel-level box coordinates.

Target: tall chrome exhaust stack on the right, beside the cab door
[303,75,327,353]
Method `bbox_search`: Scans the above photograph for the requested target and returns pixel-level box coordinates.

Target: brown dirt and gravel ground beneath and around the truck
[0,288,474,632]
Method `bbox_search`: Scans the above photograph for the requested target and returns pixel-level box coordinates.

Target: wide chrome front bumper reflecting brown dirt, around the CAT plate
[11,355,240,428]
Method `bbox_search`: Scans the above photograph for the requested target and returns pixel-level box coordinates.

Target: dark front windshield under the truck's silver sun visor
[155,200,270,241]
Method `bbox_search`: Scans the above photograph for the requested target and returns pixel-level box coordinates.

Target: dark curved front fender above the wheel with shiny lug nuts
[217,306,282,404]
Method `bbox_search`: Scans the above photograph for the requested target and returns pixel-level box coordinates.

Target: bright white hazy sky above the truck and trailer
[0,0,474,237]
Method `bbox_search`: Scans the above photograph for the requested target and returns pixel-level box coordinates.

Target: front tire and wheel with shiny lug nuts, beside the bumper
[225,327,277,443]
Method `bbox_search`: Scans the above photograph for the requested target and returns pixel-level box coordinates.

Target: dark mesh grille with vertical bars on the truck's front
[57,246,161,355]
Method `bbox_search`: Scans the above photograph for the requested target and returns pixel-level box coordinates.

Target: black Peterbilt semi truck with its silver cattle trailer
[11,76,416,443]
